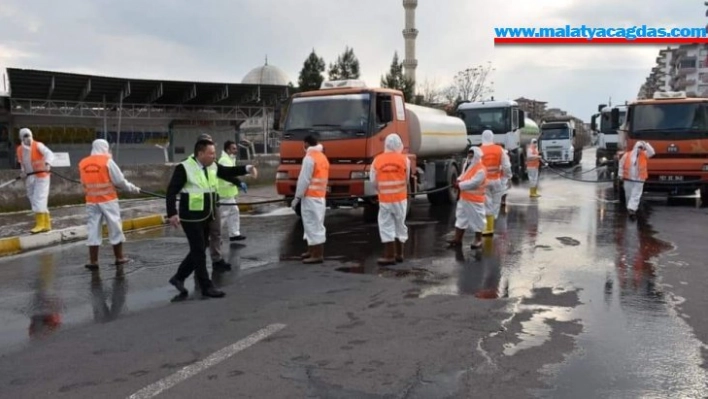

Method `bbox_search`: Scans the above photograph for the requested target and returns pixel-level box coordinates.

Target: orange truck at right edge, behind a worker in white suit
[611,92,708,204]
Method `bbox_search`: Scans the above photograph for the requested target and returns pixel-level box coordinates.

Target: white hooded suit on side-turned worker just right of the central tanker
[455,147,487,233]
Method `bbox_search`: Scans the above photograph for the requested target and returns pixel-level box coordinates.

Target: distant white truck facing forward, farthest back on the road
[538,116,583,165]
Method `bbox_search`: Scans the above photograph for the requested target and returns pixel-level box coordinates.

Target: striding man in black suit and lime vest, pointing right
[166,140,253,300]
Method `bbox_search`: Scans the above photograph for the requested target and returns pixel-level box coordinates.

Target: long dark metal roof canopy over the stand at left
[7,68,289,107]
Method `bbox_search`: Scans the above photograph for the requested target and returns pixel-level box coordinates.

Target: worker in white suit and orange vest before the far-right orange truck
[617,141,655,218]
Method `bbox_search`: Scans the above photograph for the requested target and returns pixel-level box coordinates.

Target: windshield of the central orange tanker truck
[283,93,371,140]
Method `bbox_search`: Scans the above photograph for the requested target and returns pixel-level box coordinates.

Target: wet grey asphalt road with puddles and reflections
[0,151,708,398]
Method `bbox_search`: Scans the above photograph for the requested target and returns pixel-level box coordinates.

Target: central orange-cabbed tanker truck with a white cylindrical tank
[273,80,468,221]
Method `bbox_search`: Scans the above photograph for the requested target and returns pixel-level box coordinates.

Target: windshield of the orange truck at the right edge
[630,103,708,140]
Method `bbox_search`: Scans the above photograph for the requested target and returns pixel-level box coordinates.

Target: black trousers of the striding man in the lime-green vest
[175,220,212,289]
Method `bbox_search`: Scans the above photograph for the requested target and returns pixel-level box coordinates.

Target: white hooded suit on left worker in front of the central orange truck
[292,144,327,263]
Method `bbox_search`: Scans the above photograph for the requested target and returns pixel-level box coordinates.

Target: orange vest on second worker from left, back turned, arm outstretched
[79,154,118,204]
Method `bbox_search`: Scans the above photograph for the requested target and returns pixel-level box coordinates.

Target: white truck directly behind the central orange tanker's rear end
[457,100,531,182]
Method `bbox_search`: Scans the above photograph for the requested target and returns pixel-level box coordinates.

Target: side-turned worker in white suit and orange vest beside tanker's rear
[448,147,487,249]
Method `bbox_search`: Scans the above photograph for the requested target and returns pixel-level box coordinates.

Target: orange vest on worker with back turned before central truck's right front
[374,152,408,204]
